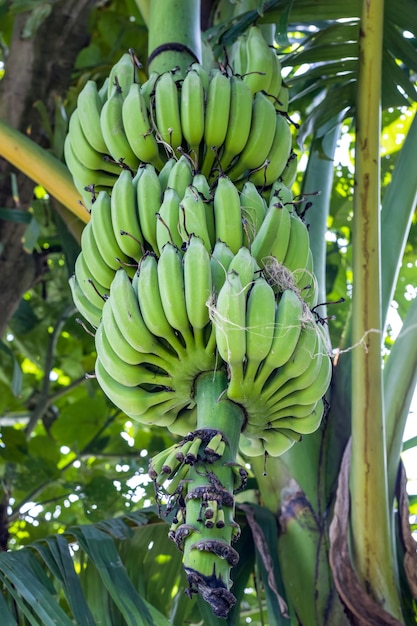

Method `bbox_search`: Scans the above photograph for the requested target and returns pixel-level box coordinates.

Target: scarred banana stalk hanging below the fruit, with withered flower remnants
[150,370,246,618]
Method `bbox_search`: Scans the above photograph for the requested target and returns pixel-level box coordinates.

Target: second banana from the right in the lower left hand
[157,243,194,350]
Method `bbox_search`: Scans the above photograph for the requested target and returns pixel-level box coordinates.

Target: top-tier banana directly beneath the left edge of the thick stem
[154,72,182,156]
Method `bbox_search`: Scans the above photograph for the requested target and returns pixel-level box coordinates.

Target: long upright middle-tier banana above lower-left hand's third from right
[136,164,162,254]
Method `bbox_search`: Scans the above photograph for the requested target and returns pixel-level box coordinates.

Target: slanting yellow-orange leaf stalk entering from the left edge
[0,120,89,223]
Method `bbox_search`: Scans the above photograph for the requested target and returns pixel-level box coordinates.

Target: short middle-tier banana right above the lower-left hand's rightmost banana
[179,185,211,251]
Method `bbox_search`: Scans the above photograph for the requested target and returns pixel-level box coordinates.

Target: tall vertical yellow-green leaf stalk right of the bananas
[350,0,401,617]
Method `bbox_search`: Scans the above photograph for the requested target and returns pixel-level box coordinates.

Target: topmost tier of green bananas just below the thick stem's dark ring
[65,26,292,196]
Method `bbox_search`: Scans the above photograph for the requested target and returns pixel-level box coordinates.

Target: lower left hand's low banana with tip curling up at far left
[95,359,174,422]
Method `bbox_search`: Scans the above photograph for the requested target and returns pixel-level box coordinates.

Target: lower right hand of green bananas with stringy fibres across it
[211,248,332,456]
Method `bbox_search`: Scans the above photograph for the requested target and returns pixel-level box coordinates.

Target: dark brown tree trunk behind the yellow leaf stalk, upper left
[0,0,95,337]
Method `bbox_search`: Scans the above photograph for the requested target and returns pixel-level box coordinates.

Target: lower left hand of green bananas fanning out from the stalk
[91,236,221,435]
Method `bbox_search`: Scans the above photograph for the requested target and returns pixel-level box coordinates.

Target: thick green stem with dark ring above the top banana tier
[148,0,201,75]
